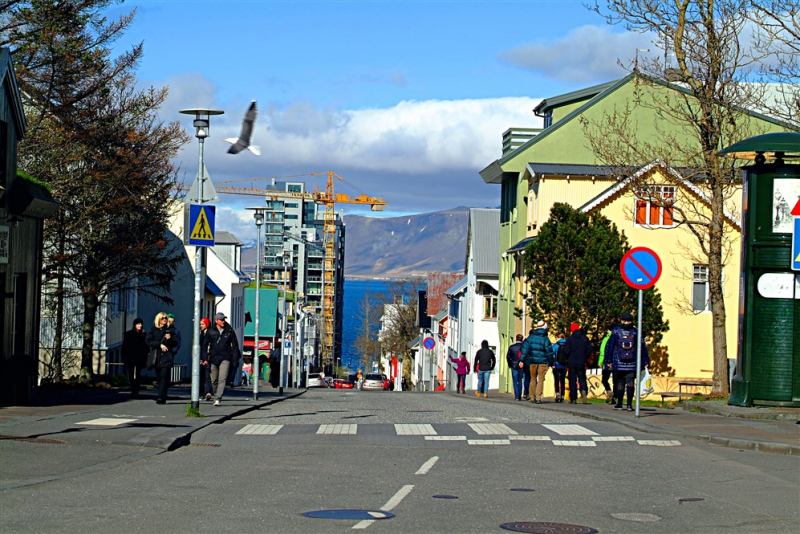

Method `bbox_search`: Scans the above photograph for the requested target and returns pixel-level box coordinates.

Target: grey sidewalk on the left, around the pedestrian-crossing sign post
[0,380,305,451]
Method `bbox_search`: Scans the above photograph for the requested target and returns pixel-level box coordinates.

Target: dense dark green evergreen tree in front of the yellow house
[524,203,669,344]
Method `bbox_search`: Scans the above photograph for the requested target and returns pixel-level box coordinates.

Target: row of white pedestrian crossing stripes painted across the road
[231,421,681,447]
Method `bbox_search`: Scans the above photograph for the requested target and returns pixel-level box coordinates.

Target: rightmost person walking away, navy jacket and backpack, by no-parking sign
[604,312,650,411]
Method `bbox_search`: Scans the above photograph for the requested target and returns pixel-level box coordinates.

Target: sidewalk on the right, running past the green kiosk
[468,392,800,456]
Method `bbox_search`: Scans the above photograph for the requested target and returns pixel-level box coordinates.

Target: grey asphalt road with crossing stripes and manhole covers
[0,390,800,534]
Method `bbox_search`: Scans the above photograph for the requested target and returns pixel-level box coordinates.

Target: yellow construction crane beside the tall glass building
[179,171,387,365]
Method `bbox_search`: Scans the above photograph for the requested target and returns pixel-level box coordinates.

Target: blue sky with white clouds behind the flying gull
[109,0,657,239]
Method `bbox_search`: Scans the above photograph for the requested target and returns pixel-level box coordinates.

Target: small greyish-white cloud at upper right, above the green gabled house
[499,26,652,84]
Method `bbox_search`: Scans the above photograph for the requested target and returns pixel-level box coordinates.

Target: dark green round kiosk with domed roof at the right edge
[720,133,800,406]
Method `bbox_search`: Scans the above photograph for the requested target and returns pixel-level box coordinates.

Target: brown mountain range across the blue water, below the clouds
[242,206,469,278]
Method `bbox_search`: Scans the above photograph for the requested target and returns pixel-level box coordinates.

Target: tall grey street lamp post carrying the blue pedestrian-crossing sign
[180,108,225,409]
